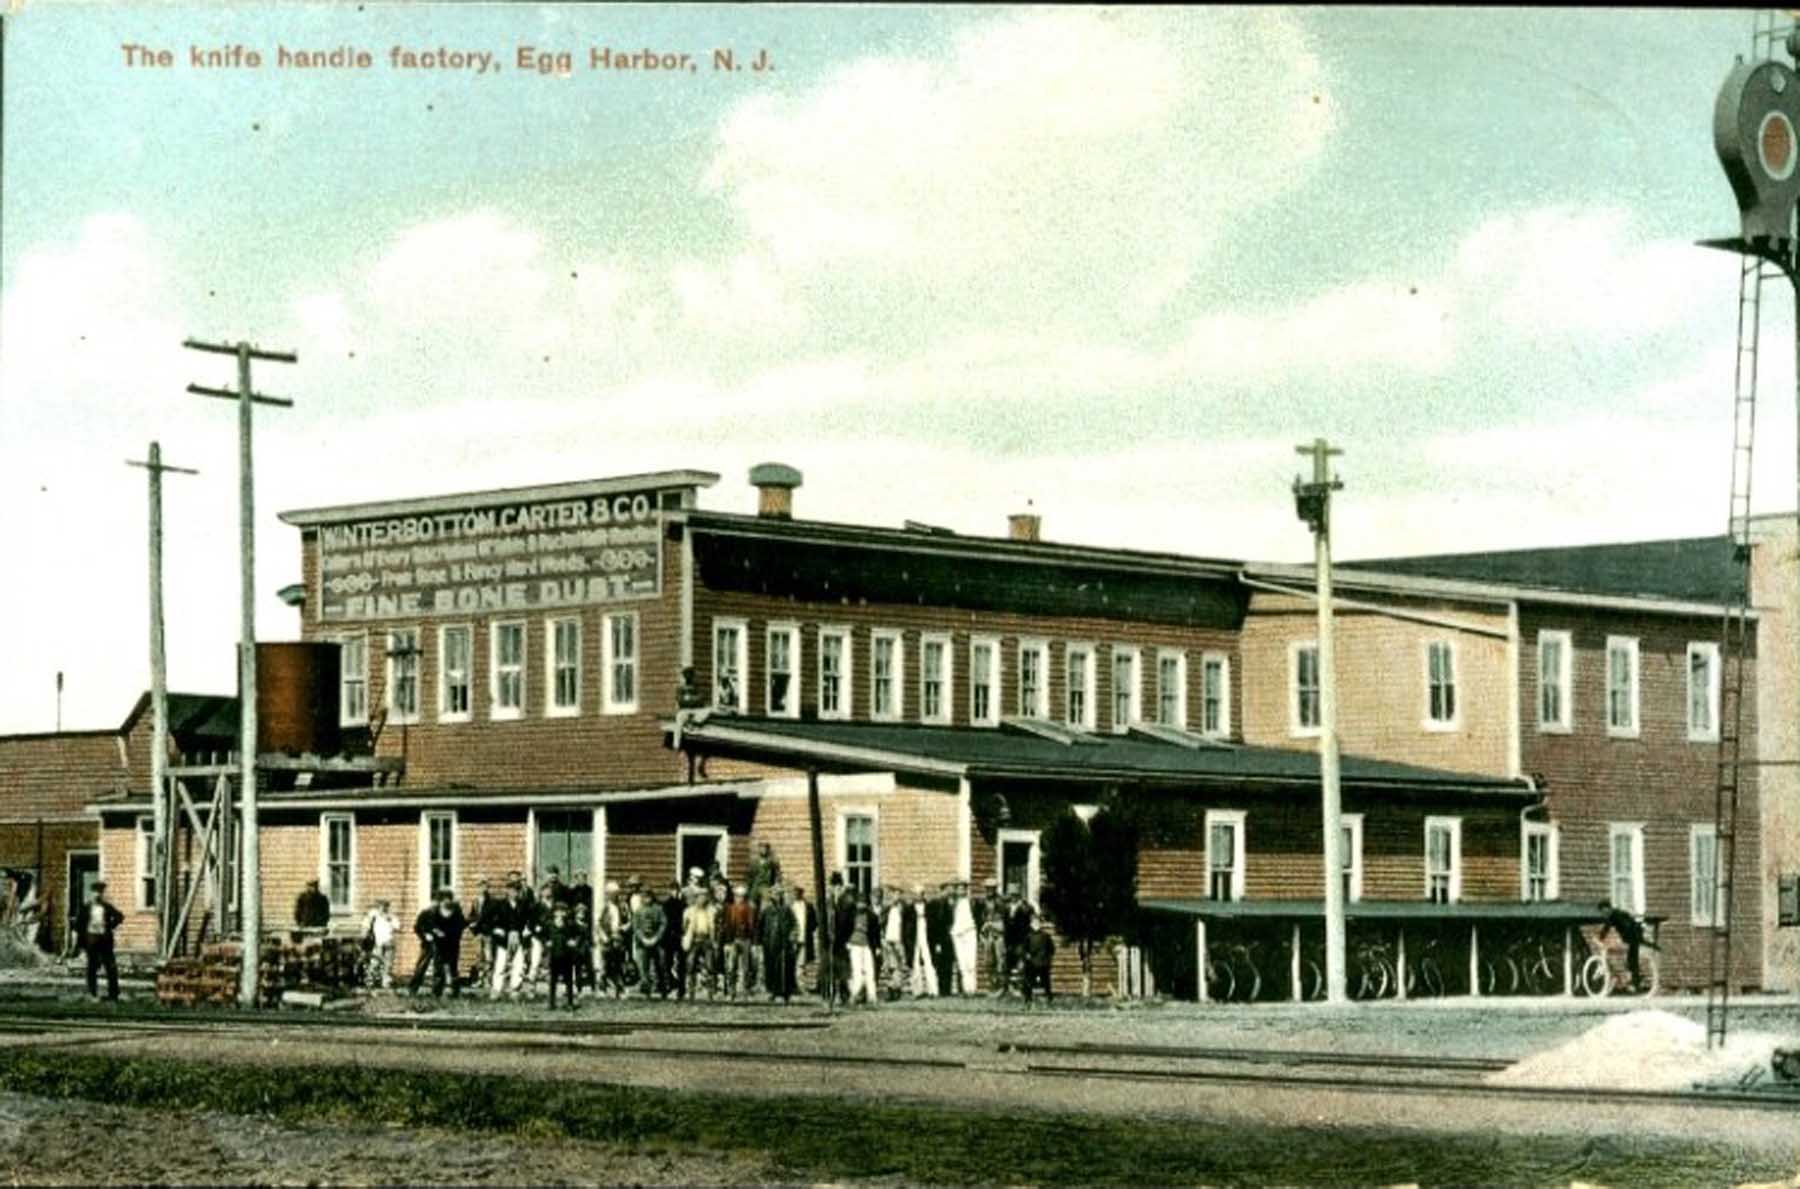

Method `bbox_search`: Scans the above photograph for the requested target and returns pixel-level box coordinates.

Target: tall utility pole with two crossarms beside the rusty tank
[182,338,301,1007]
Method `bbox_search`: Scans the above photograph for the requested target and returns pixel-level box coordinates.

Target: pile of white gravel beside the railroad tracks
[1487,1011,1791,1090]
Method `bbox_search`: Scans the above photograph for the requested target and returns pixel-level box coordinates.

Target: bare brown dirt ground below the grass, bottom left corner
[0,1094,778,1185]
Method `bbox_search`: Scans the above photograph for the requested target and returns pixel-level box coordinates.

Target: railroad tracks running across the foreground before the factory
[0,1011,1800,1115]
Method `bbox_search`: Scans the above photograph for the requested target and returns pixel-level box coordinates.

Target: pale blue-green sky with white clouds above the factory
[0,0,1796,734]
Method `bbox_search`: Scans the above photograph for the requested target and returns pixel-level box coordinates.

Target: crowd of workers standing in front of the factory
[322,842,1055,1009]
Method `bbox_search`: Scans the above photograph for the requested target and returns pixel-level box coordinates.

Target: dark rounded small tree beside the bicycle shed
[1039,808,1138,998]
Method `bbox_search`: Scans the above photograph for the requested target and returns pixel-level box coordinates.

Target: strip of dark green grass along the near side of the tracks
[0,1049,1793,1185]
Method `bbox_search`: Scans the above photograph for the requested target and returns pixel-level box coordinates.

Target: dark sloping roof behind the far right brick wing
[1339,534,1744,603]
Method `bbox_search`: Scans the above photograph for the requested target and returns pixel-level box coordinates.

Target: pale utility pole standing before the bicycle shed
[1294,437,1346,1004]
